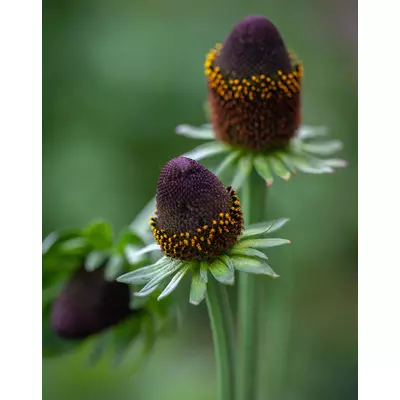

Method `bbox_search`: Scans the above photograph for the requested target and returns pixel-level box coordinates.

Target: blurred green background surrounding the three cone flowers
[43,0,357,400]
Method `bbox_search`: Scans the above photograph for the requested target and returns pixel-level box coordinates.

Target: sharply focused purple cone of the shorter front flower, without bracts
[150,157,243,260]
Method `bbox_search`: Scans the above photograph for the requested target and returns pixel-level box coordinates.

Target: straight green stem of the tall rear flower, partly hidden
[237,180,259,400]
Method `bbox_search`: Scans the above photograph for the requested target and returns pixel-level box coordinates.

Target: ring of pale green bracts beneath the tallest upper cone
[176,124,346,190]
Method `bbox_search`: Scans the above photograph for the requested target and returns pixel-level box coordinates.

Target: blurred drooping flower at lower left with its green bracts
[42,221,172,362]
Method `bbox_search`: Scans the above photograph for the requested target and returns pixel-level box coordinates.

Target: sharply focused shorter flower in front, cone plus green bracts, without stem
[117,157,290,305]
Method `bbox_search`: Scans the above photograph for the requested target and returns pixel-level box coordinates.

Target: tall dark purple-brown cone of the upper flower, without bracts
[205,16,303,152]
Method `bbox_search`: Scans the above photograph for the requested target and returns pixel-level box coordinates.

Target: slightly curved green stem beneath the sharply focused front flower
[206,278,235,400]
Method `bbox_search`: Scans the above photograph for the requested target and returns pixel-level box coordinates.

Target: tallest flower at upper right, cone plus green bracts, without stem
[176,16,346,190]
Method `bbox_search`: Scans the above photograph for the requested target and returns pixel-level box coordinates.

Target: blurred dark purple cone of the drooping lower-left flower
[51,267,132,340]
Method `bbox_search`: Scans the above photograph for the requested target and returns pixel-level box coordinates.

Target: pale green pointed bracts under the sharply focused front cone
[117,218,290,305]
